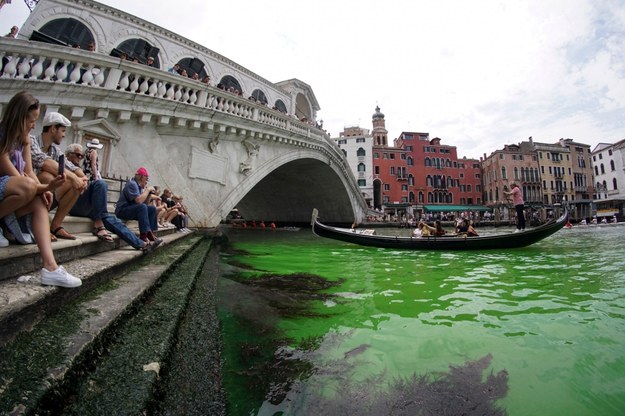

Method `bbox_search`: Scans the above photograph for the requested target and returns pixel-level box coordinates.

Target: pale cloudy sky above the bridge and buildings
[0,0,625,159]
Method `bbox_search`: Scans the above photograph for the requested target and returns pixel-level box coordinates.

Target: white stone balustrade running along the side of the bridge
[0,38,328,141]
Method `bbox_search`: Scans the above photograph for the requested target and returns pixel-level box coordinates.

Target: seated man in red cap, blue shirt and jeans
[115,167,162,244]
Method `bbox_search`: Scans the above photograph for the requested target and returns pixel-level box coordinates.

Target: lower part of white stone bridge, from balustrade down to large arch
[0,33,366,227]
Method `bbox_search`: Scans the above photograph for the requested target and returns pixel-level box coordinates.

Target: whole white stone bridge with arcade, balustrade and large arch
[0,0,366,227]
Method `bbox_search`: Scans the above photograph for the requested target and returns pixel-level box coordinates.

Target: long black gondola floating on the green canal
[311,208,569,250]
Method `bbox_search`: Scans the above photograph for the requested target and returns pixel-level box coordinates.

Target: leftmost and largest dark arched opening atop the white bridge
[30,18,94,49]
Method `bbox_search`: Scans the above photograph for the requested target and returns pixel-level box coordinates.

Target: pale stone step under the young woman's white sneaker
[0,233,194,345]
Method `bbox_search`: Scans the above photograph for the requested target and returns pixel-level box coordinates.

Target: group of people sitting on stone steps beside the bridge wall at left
[0,91,190,287]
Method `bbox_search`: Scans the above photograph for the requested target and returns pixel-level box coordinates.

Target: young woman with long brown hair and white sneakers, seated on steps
[0,91,82,287]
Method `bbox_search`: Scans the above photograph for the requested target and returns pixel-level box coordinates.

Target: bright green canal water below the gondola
[220,225,625,416]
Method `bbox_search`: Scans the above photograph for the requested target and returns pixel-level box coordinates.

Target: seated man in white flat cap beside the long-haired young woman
[30,112,87,241]
